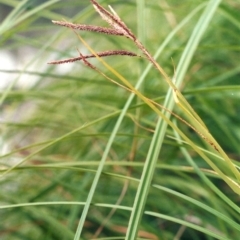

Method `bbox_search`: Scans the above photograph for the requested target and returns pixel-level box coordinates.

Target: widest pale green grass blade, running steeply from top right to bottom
[126,0,221,240]
